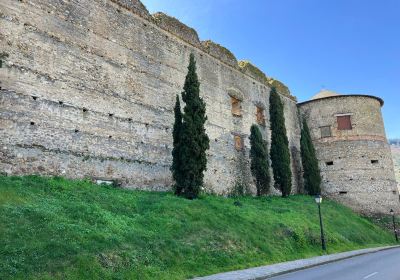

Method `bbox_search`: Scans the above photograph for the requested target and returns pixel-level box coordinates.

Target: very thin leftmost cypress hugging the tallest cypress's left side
[171,95,182,195]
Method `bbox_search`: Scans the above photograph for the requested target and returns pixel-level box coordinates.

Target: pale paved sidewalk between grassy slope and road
[193,246,400,280]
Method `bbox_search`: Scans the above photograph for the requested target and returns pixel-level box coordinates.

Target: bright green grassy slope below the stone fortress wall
[0,176,393,279]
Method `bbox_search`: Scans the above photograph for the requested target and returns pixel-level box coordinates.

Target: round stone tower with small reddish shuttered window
[298,90,400,214]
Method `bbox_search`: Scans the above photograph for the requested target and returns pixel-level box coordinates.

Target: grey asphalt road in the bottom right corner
[269,248,400,280]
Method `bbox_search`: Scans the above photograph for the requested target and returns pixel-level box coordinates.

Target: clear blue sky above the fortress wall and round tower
[142,0,400,138]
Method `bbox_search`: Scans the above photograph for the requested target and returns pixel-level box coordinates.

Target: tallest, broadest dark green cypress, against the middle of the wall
[177,54,210,199]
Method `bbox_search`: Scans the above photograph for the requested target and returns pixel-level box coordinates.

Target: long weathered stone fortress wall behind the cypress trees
[0,0,300,193]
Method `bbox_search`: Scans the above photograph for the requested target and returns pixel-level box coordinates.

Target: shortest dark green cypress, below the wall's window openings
[250,124,271,196]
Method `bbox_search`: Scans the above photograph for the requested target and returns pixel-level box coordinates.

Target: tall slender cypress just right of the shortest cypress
[269,87,292,197]
